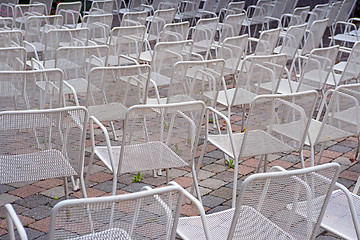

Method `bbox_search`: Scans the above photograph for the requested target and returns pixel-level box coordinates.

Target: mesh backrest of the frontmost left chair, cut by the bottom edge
[54,188,179,240]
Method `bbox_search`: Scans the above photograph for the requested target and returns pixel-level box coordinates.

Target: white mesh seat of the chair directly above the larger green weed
[95,141,188,174]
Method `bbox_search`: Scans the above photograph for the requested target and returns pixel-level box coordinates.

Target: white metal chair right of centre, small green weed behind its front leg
[198,91,317,207]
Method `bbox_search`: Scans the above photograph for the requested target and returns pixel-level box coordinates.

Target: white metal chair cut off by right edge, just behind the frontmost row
[305,84,360,165]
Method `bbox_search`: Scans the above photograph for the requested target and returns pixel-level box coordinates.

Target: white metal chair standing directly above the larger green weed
[87,101,205,196]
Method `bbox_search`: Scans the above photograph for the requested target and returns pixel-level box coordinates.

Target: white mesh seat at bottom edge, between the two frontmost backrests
[178,205,295,239]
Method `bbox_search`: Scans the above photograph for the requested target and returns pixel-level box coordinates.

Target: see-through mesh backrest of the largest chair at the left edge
[0,108,86,184]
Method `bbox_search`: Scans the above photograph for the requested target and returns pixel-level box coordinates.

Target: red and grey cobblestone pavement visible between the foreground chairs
[0,102,360,239]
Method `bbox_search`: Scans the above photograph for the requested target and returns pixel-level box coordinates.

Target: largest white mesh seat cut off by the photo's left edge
[0,149,77,184]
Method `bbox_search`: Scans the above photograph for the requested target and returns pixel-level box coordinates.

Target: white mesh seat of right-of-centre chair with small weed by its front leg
[208,130,296,157]
